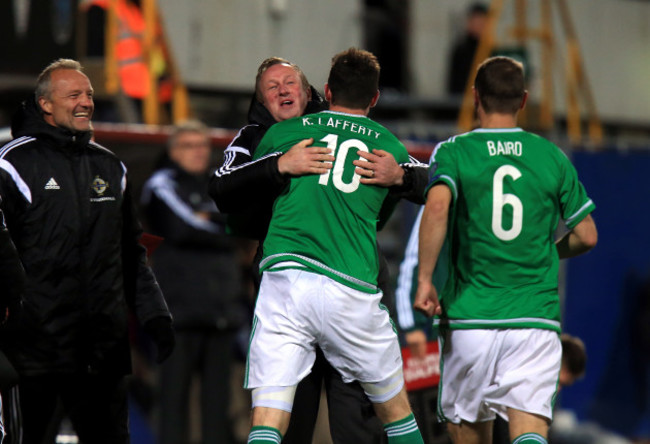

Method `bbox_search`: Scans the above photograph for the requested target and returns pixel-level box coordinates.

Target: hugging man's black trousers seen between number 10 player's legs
[282,349,388,444]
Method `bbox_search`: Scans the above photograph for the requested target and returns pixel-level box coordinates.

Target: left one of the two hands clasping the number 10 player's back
[278,139,335,176]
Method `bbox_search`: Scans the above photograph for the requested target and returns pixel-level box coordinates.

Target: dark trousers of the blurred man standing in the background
[159,329,234,444]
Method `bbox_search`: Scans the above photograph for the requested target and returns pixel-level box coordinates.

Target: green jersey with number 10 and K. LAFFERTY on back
[253,111,408,293]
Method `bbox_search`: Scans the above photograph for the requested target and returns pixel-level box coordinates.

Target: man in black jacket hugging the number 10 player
[210,57,427,444]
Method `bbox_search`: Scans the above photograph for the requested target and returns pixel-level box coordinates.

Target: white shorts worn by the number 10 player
[244,269,403,396]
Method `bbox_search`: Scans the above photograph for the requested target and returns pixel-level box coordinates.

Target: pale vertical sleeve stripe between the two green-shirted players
[395,207,424,330]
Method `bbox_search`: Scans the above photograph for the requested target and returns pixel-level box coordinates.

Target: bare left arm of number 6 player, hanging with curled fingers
[413,183,451,316]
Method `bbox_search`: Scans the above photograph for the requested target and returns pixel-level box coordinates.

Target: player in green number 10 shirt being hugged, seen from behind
[245,48,422,443]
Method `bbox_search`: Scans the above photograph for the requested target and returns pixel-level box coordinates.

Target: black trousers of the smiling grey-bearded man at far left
[15,374,130,444]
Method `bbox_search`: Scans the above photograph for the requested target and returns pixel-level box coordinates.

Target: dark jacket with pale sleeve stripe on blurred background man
[141,161,243,331]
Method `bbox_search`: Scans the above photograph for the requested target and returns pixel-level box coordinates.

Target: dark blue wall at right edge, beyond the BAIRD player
[560,151,650,439]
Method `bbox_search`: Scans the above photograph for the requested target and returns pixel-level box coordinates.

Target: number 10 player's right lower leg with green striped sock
[373,387,424,444]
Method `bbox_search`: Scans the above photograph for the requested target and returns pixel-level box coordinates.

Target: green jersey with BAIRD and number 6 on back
[429,128,595,332]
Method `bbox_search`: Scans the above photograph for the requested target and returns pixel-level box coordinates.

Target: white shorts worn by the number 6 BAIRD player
[438,328,562,424]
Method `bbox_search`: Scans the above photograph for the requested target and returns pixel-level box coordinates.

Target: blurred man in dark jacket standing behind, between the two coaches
[142,121,247,444]
